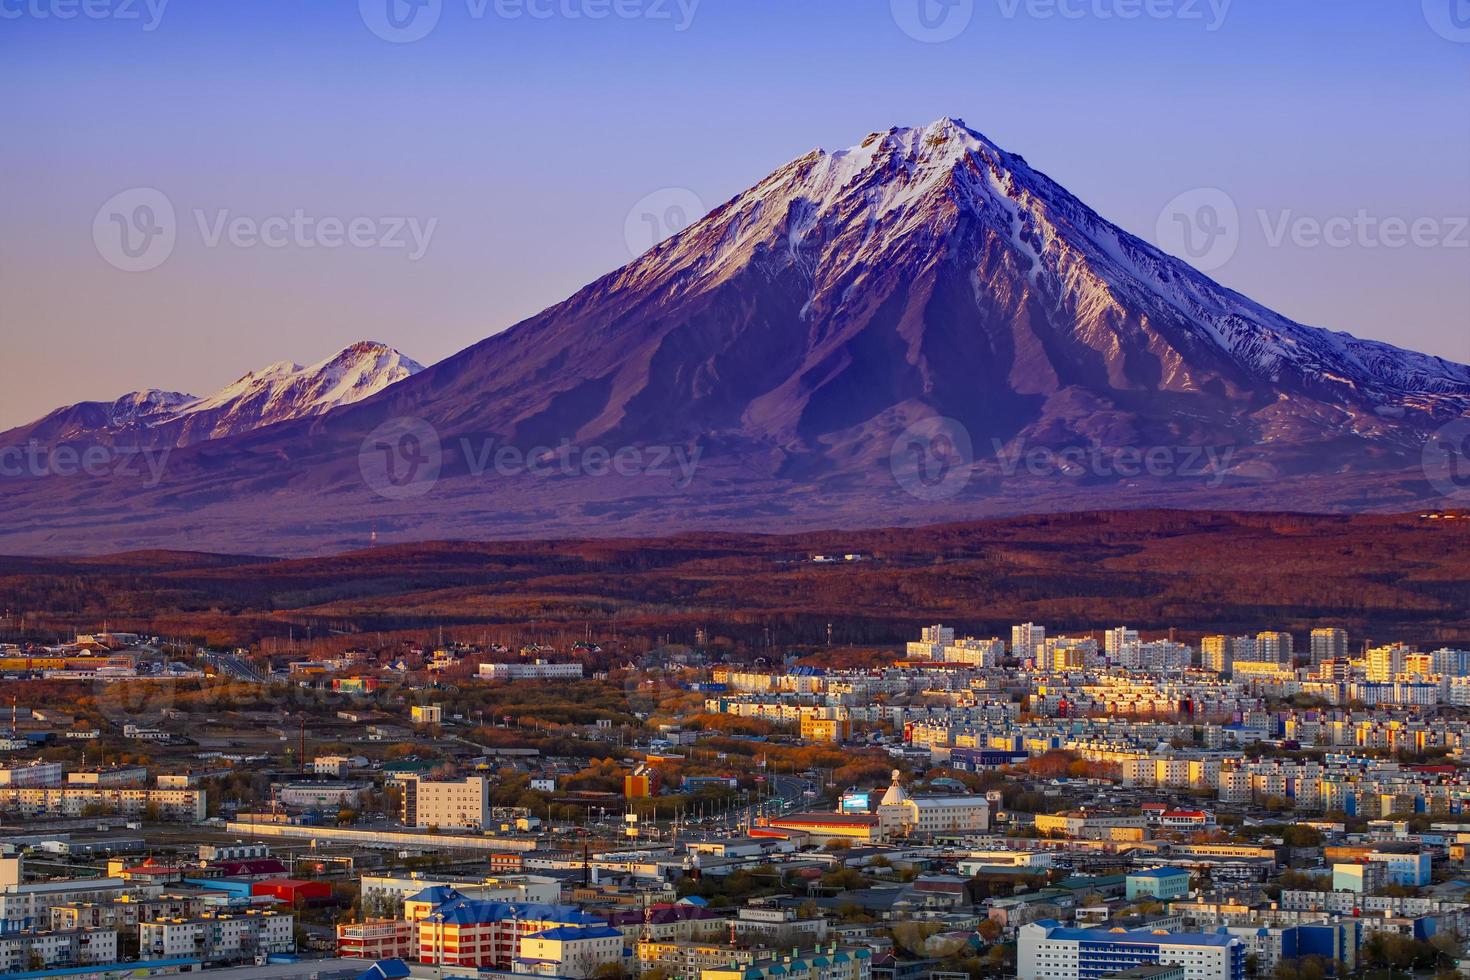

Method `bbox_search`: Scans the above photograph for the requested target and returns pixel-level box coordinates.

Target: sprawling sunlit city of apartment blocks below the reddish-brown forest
[0,623,1470,980]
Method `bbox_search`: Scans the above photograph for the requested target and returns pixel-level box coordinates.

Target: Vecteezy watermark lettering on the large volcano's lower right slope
[991,439,1235,489]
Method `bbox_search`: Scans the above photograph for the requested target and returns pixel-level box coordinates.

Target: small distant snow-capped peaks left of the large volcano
[10,341,423,447]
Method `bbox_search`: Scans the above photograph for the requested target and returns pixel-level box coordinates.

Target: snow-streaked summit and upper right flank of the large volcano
[637,116,1470,414]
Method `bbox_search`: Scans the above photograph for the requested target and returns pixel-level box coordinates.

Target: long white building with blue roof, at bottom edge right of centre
[1016,918,1245,980]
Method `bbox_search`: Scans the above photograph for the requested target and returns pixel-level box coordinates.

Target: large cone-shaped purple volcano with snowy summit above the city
[0,119,1470,554]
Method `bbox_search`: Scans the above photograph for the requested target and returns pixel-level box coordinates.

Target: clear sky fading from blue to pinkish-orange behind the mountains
[0,0,1470,428]
